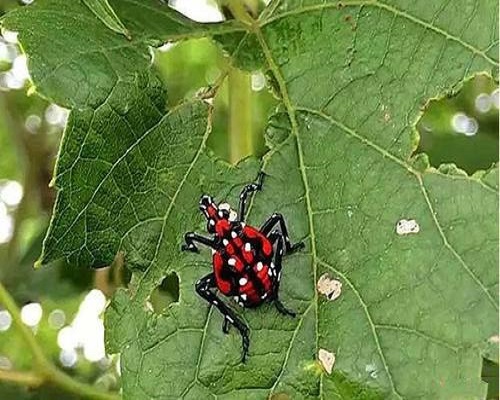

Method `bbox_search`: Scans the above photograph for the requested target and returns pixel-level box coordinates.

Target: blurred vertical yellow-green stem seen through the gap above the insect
[228,68,255,164]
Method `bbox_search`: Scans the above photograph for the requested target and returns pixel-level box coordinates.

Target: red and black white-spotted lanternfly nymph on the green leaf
[182,173,304,362]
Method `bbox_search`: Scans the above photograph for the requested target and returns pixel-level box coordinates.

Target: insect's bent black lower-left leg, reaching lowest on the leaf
[196,273,250,363]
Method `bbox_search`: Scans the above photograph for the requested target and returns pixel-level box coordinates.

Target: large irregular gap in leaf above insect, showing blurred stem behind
[154,39,277,164]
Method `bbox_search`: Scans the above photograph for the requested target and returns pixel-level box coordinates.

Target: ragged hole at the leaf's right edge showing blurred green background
[415,74,498,174]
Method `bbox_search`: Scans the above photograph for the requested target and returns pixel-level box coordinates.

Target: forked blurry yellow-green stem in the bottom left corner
[0,282,120,400]
